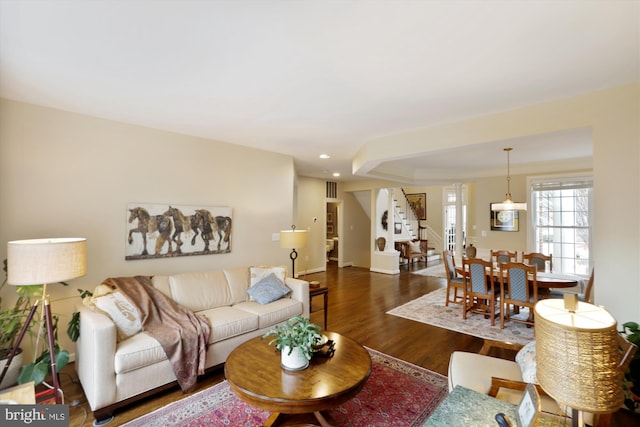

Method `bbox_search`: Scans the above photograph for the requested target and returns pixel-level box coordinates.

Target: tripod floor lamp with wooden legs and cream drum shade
[0,238,87,404]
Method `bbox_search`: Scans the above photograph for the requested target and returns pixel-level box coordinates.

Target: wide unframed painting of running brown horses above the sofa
[125,203,233,260]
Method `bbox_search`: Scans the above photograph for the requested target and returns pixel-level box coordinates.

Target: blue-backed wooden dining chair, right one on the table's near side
[500,262,538,329]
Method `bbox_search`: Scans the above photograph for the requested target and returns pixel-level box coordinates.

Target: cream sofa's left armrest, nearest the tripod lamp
[75,306,117,411]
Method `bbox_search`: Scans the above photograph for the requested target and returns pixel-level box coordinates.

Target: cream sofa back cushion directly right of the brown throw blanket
[169,271,232,311]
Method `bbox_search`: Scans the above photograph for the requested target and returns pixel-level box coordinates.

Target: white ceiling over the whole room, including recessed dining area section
[0,0,640,181]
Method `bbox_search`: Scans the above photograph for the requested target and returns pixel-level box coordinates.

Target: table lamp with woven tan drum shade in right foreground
[535,296,624,426]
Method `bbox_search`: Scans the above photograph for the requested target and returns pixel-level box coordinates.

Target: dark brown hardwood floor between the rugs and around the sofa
[61,262,638,427]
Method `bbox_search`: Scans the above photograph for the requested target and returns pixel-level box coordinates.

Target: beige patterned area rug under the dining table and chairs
[387,288,534,345]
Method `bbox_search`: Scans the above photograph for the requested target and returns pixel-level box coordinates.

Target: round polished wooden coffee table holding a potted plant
[224,331,371,426]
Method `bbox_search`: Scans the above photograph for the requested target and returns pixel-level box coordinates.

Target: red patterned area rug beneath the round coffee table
[123,349,447,427]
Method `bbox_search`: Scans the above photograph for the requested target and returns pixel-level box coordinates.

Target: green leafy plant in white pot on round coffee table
[262,316,322,370]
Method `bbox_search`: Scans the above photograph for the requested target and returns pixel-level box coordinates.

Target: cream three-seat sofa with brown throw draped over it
[76,267,309,422]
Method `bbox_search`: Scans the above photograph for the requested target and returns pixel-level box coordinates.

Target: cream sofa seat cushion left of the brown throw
[113,332,167,374]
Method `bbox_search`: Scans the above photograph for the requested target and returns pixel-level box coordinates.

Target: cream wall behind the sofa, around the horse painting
[0,99,294,352]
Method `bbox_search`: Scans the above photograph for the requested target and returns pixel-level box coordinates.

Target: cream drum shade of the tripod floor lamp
[7,237,87,286]
